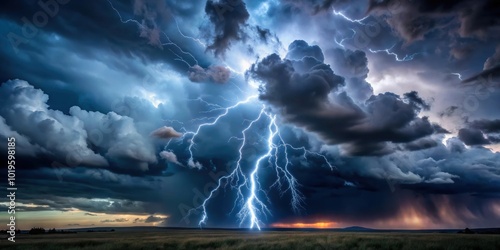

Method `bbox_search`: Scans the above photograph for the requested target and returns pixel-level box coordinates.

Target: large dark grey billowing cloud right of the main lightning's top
[248,41,444,155]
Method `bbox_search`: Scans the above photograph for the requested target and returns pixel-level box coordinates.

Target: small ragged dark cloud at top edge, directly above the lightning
[205,0,250,56]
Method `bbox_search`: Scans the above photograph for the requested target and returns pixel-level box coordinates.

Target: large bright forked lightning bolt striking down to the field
[180,100,334,230]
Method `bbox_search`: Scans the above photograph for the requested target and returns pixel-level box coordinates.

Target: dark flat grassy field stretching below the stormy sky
[0,230,500,250]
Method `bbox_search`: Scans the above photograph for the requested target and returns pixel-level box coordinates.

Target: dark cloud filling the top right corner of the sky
[369,0,500,42]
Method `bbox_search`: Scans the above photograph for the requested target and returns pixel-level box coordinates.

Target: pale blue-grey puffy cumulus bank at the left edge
[0,80,156,172]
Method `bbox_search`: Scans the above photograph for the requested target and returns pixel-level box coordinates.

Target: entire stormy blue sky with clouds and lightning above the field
[0,0,500,229]
